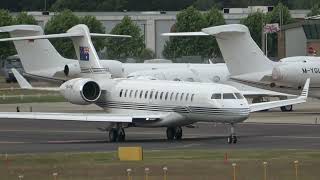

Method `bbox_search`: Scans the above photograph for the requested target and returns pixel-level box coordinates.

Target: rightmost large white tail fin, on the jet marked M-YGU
[202,24,273,76]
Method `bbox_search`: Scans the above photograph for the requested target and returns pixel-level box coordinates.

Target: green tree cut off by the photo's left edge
[0,10,16,58]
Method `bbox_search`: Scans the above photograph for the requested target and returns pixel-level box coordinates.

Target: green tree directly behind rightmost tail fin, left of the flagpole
[240,12,265,47]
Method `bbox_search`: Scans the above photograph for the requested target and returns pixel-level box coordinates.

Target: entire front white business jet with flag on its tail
[0,25,309,143]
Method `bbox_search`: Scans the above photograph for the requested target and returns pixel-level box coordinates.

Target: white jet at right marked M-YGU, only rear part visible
[164,24,320,101]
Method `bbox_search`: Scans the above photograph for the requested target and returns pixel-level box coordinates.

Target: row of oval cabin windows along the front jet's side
[119,89,194,102]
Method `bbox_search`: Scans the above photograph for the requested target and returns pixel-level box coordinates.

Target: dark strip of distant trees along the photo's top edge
[0,0,320,12]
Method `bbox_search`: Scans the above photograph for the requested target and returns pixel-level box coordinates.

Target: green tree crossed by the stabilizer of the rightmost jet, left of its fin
[163,6,225,59]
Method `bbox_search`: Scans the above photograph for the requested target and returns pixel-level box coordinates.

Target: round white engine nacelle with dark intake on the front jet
[60,78,101,105]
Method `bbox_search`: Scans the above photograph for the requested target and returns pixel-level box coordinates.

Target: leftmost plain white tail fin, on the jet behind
[0,25,75,76]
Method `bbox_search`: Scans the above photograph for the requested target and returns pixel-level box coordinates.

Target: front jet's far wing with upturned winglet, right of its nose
[250,78,310,112]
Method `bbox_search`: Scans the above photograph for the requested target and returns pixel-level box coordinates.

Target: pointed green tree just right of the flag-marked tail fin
[106,16,145,61]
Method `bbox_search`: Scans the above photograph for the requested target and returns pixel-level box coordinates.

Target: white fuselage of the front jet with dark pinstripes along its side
[81,79,250,127]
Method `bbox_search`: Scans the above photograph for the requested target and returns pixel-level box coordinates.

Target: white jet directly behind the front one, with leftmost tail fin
[0,25,292,111]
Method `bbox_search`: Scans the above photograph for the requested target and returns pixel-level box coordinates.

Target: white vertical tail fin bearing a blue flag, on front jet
[67,24,110,77]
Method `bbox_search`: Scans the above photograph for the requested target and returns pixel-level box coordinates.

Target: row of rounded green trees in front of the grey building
[0,3,320,61]
